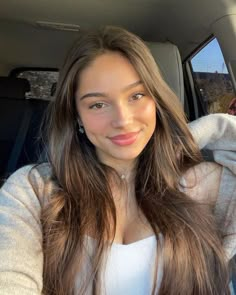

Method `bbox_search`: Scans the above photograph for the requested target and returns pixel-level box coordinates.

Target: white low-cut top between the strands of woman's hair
[76,235,162,295]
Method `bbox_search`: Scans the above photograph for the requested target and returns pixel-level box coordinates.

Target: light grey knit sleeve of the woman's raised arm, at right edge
[189,114,236,259]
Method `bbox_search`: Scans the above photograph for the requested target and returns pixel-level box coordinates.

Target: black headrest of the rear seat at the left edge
[0,77,30,99]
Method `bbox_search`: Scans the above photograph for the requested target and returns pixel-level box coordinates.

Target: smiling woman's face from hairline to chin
[76,52,156,168]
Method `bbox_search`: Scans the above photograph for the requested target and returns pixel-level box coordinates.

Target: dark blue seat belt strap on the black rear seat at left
[6,107,33,173]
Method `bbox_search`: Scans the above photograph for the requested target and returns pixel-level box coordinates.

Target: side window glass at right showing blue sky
[191,38,235,113]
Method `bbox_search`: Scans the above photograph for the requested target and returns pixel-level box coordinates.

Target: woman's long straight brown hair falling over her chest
[32,27,229,295]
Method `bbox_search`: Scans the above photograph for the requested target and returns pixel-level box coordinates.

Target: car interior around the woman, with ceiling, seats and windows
[0,0,236,288]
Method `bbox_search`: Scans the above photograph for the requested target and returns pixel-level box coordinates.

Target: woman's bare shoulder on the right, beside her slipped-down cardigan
[183,162,222,203]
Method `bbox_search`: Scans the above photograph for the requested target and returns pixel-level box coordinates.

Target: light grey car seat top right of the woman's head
[146,42,184,104]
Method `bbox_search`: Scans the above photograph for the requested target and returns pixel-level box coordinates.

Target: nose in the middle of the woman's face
[112,104,133,128]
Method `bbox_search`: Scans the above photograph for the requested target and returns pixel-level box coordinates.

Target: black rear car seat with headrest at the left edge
[0,77,48,183]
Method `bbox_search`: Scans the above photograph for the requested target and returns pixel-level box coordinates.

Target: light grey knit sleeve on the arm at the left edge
[0,166,43,295]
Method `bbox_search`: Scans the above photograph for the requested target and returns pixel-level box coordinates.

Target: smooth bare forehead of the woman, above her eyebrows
[77,52,140,94]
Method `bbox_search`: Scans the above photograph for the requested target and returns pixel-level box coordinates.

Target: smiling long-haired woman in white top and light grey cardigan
[0,27,235,295]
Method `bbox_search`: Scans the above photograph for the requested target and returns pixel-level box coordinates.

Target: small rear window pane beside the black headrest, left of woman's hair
[17,70,58,100]
